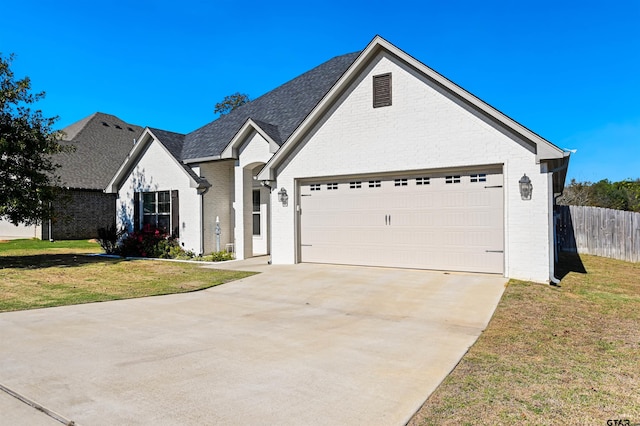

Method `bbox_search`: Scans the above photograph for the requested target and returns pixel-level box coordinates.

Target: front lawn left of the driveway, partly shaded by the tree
[0,240,254,312]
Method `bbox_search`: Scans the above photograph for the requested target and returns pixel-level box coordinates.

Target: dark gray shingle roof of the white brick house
[181,52,359,160]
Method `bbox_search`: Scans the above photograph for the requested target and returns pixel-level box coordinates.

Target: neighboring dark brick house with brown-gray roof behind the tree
[0,112,142,240]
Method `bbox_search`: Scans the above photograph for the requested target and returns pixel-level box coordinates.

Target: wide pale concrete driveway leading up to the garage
[0,259,506,425]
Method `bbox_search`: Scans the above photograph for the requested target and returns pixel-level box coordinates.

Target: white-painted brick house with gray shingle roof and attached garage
[107,37,569,282]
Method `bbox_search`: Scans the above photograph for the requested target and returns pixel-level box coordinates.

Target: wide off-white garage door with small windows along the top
[300,169,504,273]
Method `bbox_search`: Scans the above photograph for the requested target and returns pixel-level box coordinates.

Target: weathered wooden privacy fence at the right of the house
[556,206,640,262]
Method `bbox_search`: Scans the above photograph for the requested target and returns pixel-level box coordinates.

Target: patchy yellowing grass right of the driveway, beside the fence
[409,256,640,426]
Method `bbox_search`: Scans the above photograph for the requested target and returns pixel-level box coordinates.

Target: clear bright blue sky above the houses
[0,0,640,181]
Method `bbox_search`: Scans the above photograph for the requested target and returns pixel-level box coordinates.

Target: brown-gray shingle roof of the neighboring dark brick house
[53,112,143,190]
